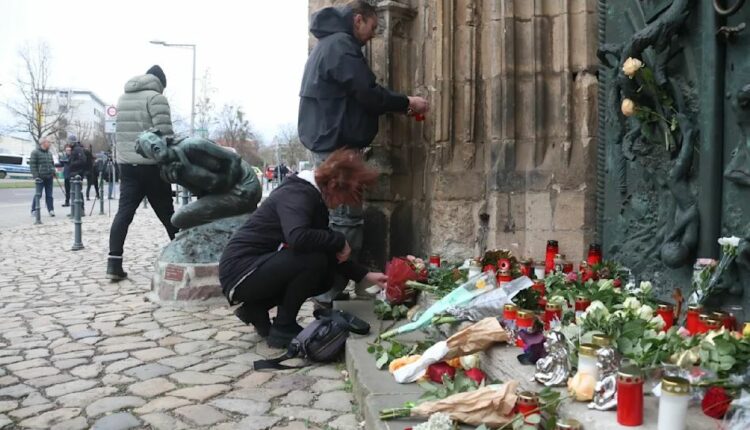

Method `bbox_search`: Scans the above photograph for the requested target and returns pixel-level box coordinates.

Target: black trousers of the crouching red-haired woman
[232,249,335,325]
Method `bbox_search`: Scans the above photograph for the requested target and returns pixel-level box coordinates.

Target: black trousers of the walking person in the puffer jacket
[109,164,177,256]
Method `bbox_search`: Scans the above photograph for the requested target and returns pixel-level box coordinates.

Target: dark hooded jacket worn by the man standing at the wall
[298,6,409,152]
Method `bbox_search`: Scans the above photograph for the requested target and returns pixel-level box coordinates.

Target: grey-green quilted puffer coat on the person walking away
[115,75,173,164]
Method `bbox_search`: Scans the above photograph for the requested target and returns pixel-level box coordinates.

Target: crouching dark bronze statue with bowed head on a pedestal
[136,130,262,229]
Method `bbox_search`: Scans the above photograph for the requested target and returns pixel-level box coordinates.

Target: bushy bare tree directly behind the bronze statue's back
[215,105,263,166]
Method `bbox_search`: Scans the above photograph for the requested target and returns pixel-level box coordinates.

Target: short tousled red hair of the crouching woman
[315,149,378,204]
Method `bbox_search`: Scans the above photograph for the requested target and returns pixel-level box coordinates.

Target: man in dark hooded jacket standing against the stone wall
[298,0,429,303]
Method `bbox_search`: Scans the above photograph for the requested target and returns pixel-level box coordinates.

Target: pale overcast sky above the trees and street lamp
[0,0,308,141]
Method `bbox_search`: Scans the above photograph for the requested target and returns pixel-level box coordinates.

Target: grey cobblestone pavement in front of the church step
[0,210,358,430]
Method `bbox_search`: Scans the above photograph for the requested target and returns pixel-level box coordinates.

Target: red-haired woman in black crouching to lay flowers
[219,149,387,348]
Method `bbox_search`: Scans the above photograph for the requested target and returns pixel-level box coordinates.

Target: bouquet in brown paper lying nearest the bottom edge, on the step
[380,381,518,427]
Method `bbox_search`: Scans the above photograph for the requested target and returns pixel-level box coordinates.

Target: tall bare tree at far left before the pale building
[6,42,67,145]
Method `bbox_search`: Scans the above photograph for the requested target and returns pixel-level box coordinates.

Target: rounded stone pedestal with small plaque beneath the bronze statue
[148,215,248,304]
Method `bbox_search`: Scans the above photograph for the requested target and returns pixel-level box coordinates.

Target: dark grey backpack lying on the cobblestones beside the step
[253,309,370,370]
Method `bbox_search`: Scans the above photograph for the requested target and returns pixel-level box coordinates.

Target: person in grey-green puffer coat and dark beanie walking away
[107,65,177,281]
